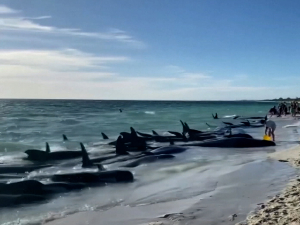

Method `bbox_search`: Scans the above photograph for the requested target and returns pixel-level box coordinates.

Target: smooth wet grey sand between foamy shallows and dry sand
[44,159,295,225]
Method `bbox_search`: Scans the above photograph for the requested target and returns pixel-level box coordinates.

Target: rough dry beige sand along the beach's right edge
[245,146,300,225]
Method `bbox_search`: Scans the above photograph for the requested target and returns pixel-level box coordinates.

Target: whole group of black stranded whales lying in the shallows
[0,114,276,207]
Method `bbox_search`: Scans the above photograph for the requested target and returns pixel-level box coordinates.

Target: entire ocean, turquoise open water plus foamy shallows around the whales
[0,100,299,224]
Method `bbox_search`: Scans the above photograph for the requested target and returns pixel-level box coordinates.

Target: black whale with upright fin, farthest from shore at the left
[25,142,82,161]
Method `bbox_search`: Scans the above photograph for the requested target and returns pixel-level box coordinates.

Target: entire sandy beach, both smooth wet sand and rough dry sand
[43,118,300,225]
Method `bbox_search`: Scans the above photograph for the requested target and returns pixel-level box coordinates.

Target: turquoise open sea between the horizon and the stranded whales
[0,100,274,147]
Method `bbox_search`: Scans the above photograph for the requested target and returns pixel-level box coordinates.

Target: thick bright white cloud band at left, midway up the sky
[0,49,130,72]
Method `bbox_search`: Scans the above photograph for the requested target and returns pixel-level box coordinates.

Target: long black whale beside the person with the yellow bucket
[181,137,276,148]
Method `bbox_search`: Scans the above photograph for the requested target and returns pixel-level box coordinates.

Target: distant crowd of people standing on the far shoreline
[269,101,300,117]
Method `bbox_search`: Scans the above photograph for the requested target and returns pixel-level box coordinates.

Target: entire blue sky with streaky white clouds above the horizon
[0,0,300,100]
